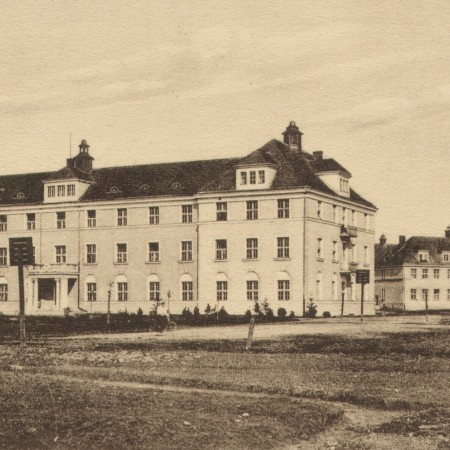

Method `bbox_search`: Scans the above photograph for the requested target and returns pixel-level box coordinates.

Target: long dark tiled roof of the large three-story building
[0,139,375,208]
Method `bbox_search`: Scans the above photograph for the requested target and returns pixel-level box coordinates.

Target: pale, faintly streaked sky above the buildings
[0,0,450,243]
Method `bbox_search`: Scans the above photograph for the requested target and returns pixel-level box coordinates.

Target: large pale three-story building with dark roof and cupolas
[0,122,376,315]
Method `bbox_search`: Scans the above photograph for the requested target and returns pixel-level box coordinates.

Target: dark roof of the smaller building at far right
[375,236,450,268]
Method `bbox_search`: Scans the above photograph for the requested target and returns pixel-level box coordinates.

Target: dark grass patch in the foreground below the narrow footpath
[0,373,342,449]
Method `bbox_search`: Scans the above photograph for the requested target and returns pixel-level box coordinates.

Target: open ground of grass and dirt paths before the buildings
[0,316,450,450]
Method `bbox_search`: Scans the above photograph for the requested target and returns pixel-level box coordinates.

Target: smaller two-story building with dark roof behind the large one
[375,226,450,311]
